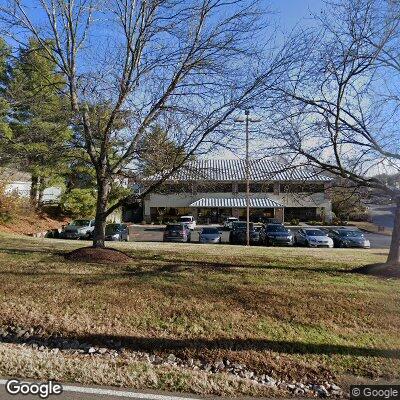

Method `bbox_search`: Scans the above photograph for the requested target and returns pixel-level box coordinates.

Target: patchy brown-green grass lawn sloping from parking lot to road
[0,235,400,395]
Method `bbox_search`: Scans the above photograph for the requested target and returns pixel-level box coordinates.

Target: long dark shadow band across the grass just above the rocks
[3,334,400,359]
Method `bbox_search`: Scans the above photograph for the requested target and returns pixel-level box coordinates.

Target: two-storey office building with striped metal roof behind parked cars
[143,159,331,223]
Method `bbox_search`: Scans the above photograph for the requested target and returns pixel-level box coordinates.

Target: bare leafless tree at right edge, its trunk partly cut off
[263,0,400,265]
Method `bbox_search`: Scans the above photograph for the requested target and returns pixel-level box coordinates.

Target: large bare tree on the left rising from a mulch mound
[0,0,289,247]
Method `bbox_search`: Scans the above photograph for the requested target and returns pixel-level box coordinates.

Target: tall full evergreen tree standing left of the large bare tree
[6,40,71,204]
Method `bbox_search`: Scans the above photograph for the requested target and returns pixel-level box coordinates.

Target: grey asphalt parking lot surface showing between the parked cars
[130,225,390,249]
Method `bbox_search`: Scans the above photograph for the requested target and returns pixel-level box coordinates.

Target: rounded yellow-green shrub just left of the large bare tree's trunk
[60,189,96,218]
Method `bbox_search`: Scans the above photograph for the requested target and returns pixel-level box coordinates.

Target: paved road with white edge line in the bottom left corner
[0,379,200,400]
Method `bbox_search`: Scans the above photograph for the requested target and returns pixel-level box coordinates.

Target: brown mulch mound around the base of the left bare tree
[65,247,132,264]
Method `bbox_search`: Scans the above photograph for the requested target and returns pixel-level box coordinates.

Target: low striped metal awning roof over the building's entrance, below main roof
[189,197,283,208]
